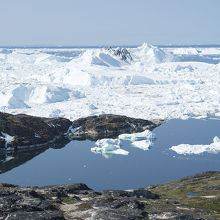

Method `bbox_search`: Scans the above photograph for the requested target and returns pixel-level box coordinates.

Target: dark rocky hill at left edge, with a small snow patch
[0,112,71,149]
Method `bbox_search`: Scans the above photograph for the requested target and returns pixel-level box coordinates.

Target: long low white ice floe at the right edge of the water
[170,136,220,155]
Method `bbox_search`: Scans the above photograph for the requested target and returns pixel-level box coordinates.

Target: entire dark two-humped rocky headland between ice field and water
[0,112,163,150]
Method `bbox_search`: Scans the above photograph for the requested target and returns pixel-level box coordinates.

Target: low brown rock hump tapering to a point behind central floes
[72,114,164,140]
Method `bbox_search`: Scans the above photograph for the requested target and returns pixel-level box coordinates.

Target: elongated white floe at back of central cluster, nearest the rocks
[118,130,155,141]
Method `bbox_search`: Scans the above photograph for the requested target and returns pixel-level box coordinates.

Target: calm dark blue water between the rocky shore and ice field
[0,119,220,191]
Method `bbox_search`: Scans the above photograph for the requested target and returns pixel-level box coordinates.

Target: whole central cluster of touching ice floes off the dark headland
[91,130,155,158]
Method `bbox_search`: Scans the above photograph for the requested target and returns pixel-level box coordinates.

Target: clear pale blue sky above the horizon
[0,0,220,46]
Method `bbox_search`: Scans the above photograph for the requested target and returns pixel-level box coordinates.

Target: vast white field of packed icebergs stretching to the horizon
[0,43,220,120]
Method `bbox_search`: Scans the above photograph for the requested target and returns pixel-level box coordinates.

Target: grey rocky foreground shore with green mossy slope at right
[0,172,220,220]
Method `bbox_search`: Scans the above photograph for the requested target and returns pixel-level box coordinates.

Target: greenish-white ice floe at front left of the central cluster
[91,139,129,156]
